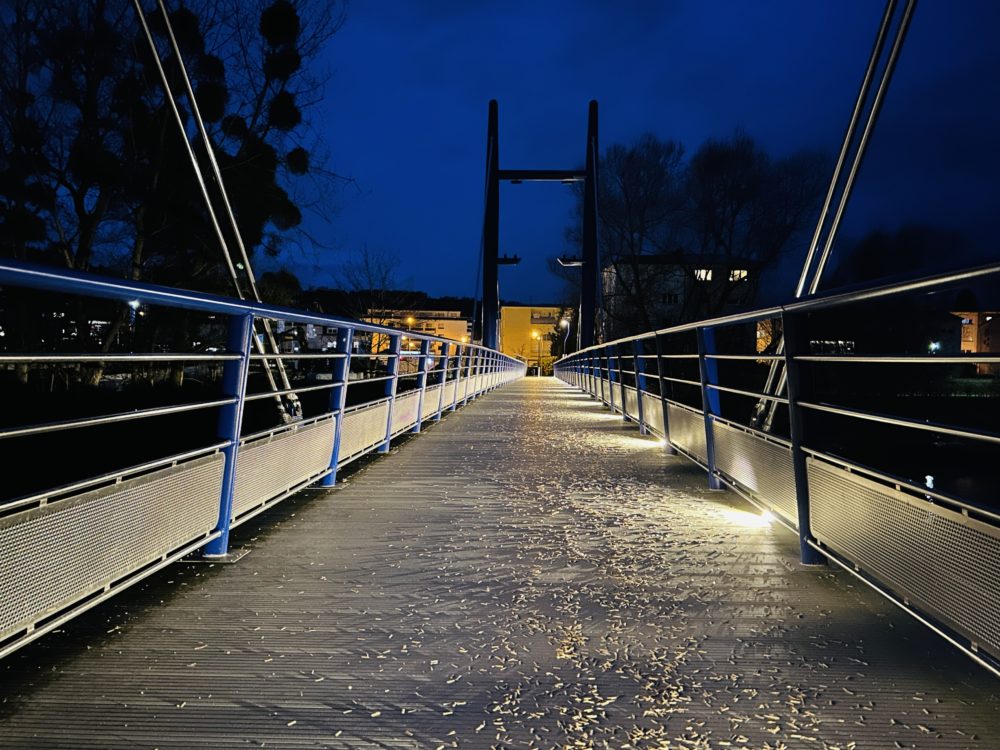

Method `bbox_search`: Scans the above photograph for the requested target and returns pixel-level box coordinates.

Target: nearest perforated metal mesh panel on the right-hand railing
[807,458,1000,656]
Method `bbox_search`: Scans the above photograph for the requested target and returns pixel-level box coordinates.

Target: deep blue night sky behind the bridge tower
[283,0,1000,302]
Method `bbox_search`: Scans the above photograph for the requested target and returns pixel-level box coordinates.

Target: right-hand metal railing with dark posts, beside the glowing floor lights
[555,264,1000,675]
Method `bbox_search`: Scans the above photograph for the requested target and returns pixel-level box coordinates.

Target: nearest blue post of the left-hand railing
[202,313,253,559]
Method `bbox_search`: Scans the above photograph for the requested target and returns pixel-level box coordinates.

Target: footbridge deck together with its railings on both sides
[0,258,1000,750]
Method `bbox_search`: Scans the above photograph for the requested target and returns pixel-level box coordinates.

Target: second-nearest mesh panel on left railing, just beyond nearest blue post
[233,417,336,518]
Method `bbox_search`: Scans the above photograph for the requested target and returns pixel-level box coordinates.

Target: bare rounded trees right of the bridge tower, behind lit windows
[560,132,828,338]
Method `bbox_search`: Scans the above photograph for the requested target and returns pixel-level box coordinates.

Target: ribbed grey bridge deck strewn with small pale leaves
[0,379,1000,750]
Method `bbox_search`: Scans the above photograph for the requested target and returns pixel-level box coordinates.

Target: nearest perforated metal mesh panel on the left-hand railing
[0,454,224,639]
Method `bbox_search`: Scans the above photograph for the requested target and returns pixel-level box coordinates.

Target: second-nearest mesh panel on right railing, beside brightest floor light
[712,422,798,524]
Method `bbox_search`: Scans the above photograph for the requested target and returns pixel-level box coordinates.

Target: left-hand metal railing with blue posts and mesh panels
[0,261,525,657]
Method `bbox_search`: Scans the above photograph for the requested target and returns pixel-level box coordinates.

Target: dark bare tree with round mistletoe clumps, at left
[0,0,344,378]
